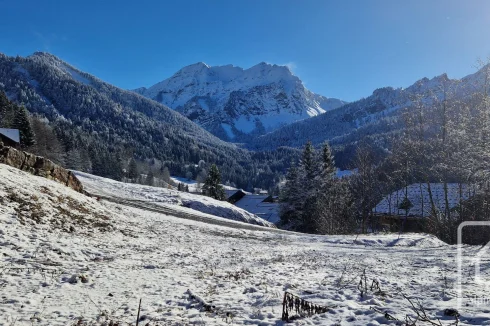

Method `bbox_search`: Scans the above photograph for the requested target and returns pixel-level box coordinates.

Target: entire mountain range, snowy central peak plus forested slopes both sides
[0,52,488,177]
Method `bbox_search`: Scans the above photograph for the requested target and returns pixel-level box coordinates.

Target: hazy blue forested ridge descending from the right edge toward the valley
[250,66,488,160]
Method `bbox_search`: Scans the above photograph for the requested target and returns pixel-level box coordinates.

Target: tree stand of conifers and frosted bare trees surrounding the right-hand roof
[281,65,490,244]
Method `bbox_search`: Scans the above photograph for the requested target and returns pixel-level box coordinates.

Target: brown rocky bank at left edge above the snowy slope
[0,145,83,193]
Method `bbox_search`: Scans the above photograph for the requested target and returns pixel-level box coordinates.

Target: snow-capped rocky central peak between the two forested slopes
[134,62,345,141]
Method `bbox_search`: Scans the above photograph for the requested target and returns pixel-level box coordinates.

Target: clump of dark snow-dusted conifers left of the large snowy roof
[280,142,354,234]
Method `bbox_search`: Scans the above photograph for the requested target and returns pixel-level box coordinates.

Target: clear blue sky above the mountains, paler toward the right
[0,0,490,101]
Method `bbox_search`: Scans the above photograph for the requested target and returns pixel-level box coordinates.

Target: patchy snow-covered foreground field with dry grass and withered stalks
[0,165,490,326]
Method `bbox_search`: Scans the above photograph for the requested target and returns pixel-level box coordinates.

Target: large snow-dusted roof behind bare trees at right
[373,183,476,217]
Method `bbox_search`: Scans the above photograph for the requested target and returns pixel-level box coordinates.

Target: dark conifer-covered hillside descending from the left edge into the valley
[0,52,296,188]
